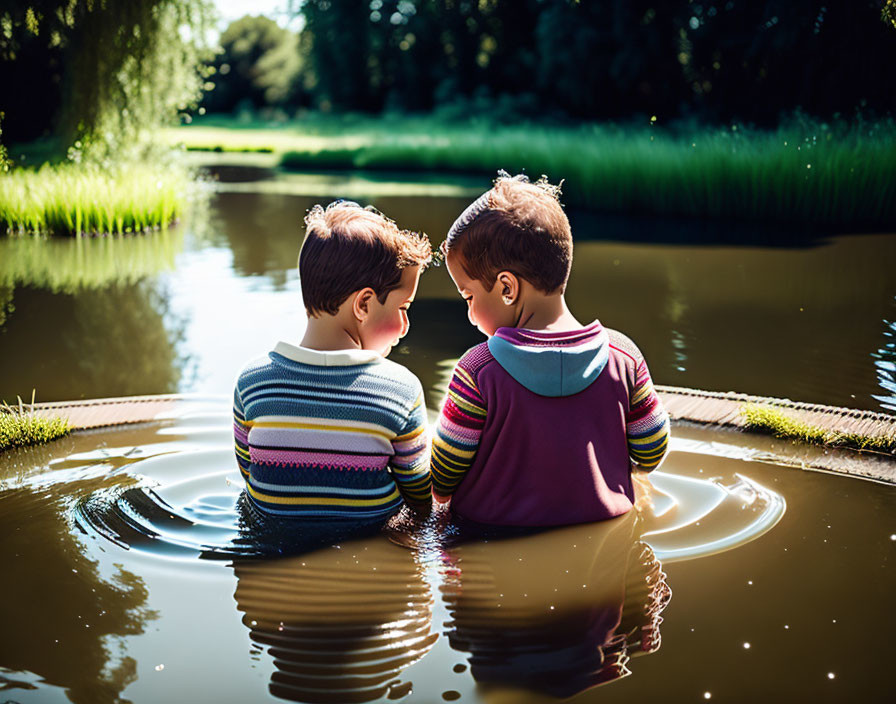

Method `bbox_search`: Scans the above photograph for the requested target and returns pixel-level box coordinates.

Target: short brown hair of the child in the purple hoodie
[441,172,572,293]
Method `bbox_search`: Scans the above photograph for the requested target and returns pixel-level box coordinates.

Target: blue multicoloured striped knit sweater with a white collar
[233,342,431,521]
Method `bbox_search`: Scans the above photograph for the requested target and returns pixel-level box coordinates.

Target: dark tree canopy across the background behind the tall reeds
[298,0,896,122]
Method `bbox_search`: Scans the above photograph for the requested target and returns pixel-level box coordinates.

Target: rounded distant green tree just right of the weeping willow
[203,16,302,111]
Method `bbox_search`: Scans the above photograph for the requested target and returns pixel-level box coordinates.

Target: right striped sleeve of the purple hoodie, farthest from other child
[625,359,669,470]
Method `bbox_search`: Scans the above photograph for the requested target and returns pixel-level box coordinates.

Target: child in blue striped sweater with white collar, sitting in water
[233,201,432,525]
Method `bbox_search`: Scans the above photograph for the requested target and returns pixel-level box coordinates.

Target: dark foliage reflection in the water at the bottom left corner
[0,472,155,704]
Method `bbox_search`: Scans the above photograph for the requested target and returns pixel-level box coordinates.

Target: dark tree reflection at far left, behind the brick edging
[0,281,190,402]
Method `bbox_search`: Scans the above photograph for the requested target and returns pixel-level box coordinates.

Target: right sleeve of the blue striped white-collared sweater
[390,389,432,511]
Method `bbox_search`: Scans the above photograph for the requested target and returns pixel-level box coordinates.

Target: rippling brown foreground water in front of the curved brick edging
[0,401,896,704]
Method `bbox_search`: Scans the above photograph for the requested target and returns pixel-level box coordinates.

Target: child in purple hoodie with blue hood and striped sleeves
[432,174,669,526]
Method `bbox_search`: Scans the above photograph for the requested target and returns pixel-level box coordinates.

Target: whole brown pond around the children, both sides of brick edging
[0,171,896,704]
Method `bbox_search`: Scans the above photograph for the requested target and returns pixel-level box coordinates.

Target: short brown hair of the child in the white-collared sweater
[299,201,432,316]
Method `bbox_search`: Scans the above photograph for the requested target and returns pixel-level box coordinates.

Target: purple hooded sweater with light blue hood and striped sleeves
[432,321,669,525]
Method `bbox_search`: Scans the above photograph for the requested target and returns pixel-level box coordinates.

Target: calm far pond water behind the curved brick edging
[0,169,896,411]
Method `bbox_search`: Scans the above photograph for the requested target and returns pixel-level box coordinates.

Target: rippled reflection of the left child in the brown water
[234,536,438,702]
